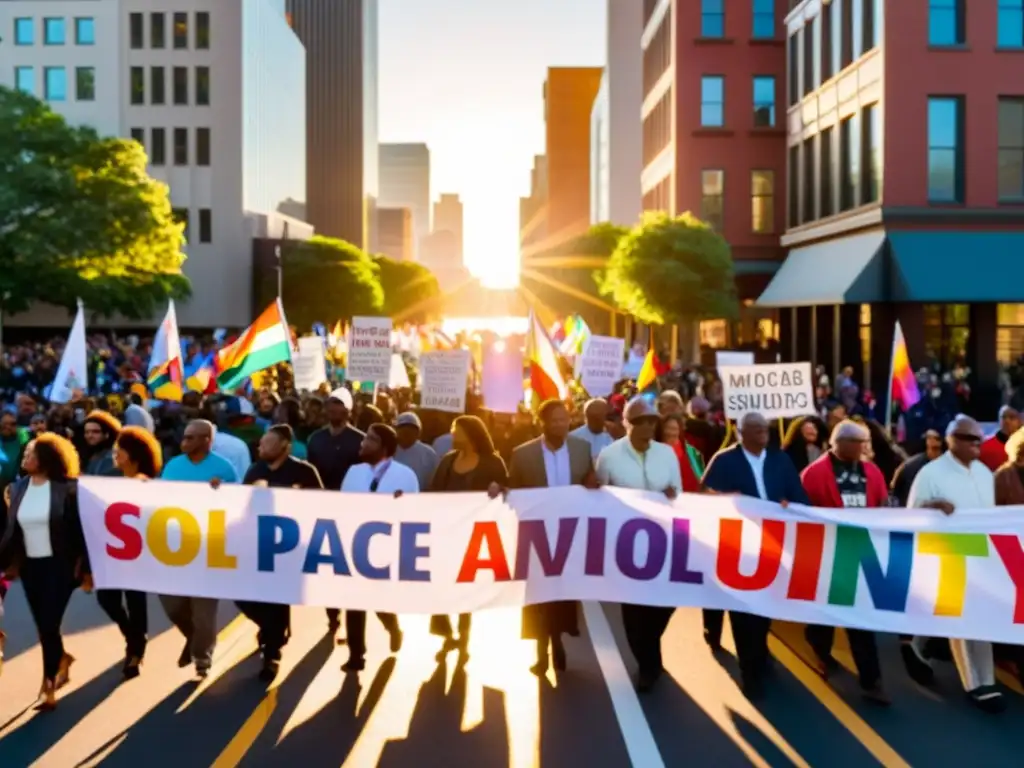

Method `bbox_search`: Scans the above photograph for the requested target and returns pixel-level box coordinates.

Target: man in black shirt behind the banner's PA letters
[236,424,324,682]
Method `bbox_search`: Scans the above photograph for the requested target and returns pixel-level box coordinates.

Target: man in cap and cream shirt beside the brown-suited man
[597,396,683,693]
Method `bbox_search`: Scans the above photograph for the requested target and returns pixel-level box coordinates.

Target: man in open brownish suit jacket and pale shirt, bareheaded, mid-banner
[509,400,597,676]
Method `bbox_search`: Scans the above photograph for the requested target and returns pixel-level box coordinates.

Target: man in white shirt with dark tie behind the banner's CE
[341,424,420,672]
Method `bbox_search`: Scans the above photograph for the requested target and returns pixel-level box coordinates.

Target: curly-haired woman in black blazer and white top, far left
[0,433,92,711]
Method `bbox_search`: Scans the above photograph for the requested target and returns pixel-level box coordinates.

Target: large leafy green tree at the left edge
[0,87,189,318]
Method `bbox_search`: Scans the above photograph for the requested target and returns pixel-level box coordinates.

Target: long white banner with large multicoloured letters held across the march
[79,477,1024,644]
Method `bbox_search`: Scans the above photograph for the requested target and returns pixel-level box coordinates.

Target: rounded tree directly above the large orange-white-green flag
[282,237,384,328]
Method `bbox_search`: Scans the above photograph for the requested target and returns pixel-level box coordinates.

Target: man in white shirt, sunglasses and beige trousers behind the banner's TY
[901,414,1006,713]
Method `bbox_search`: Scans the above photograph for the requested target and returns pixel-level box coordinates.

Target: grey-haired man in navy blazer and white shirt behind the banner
[701,412,808,698]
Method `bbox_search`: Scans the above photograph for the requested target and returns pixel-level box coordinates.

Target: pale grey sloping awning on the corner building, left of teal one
[757,229,886,307]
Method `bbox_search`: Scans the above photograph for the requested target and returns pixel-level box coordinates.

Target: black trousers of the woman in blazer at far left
[20,557,78,680]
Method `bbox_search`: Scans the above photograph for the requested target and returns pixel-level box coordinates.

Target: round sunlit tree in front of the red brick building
[601,213,739,325]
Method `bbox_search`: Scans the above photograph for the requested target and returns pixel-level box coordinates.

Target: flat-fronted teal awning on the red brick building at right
[892,229,1024,304]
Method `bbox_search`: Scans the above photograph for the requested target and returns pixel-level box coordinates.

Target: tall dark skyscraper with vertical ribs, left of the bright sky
[287,0,379,251]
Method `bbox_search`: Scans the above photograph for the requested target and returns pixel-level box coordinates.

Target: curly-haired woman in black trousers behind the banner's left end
[96,427,164,680]
